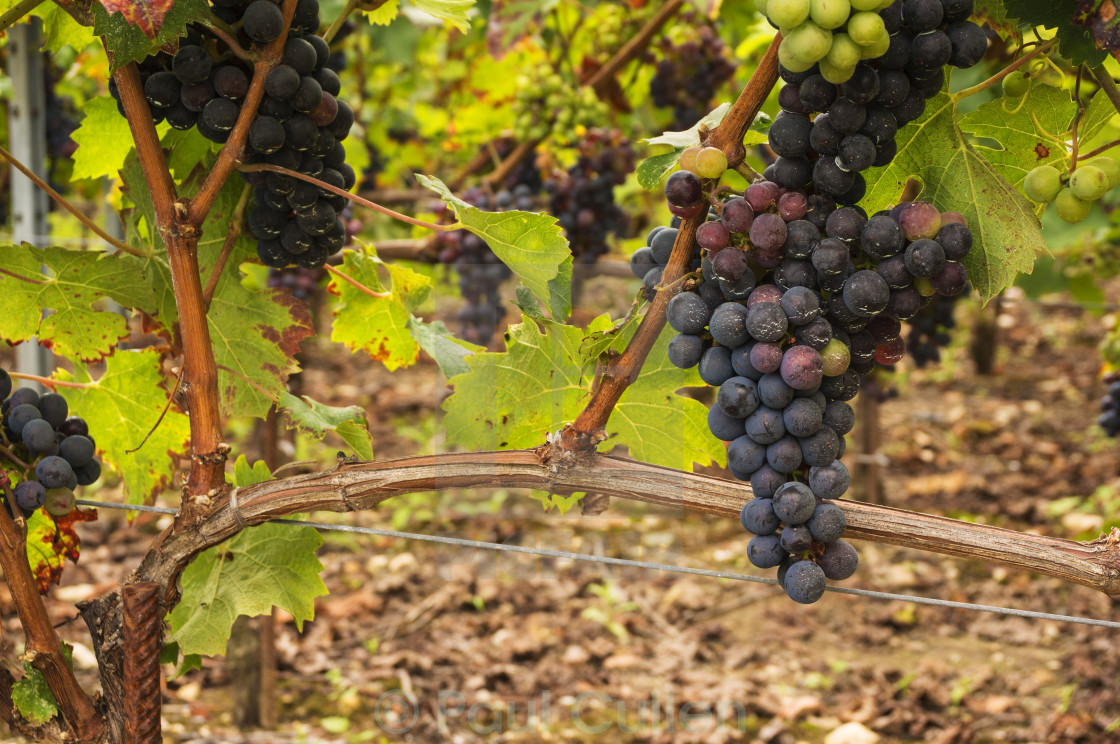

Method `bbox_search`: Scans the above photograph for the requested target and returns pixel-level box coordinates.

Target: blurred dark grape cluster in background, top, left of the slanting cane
[650,18,735,130]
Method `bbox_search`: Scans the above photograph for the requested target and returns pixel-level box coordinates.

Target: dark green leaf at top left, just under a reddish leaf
[91,0,211,72]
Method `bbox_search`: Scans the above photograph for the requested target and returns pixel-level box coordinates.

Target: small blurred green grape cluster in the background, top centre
[513,65,608,141]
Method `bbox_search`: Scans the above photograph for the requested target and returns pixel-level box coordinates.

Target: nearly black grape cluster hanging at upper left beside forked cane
[109,0,356,269]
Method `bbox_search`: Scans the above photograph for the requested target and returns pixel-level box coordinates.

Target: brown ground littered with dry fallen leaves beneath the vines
[0,273,1120,744]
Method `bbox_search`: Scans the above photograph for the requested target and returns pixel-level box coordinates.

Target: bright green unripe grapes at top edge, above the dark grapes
[755,0,892,84]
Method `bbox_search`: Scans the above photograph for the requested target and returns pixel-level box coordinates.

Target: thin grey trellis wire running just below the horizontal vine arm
[76,499,1120,630]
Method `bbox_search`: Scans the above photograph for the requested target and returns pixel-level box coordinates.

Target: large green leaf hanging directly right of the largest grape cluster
[862,93,1046,301]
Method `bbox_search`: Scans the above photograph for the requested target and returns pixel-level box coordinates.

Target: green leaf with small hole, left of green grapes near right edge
[960,85,1077,189]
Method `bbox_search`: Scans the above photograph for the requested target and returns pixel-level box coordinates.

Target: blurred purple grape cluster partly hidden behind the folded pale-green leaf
[435,187,512,346]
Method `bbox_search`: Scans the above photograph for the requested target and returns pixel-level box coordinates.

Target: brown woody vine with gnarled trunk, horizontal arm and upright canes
[0,10,1120,743]
